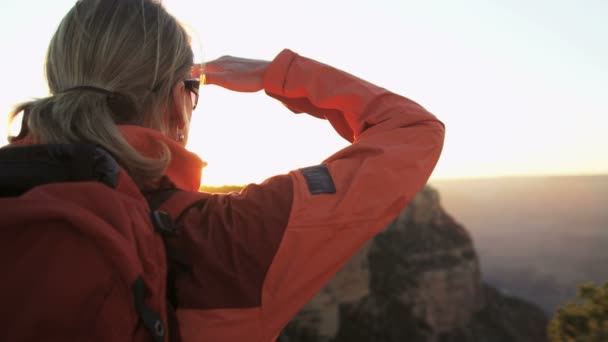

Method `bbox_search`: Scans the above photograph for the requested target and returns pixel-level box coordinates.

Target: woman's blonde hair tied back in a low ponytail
[11,0,193,186]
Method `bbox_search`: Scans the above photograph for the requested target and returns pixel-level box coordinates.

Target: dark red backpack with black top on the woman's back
[0,145,202,342]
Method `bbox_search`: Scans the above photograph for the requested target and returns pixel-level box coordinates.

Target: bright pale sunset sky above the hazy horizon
[0,0,608,185]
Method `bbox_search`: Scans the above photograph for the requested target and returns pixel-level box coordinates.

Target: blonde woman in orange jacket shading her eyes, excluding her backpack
[3,0,444,341]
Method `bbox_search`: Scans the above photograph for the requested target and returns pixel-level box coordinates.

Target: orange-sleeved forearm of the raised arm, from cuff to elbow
[264,50,442,142]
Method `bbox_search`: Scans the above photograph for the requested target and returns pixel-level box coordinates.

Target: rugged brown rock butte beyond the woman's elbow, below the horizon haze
[279,187,547,342]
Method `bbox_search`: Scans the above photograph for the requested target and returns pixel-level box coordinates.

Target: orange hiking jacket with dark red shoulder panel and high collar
[123,50,444,342]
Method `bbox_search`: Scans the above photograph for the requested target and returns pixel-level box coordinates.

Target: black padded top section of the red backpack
[0,144,120,197]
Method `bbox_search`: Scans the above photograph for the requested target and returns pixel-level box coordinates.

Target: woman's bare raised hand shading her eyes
[204,56,270,92]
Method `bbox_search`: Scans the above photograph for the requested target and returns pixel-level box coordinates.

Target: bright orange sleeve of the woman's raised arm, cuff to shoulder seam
[262,50,444,336]
